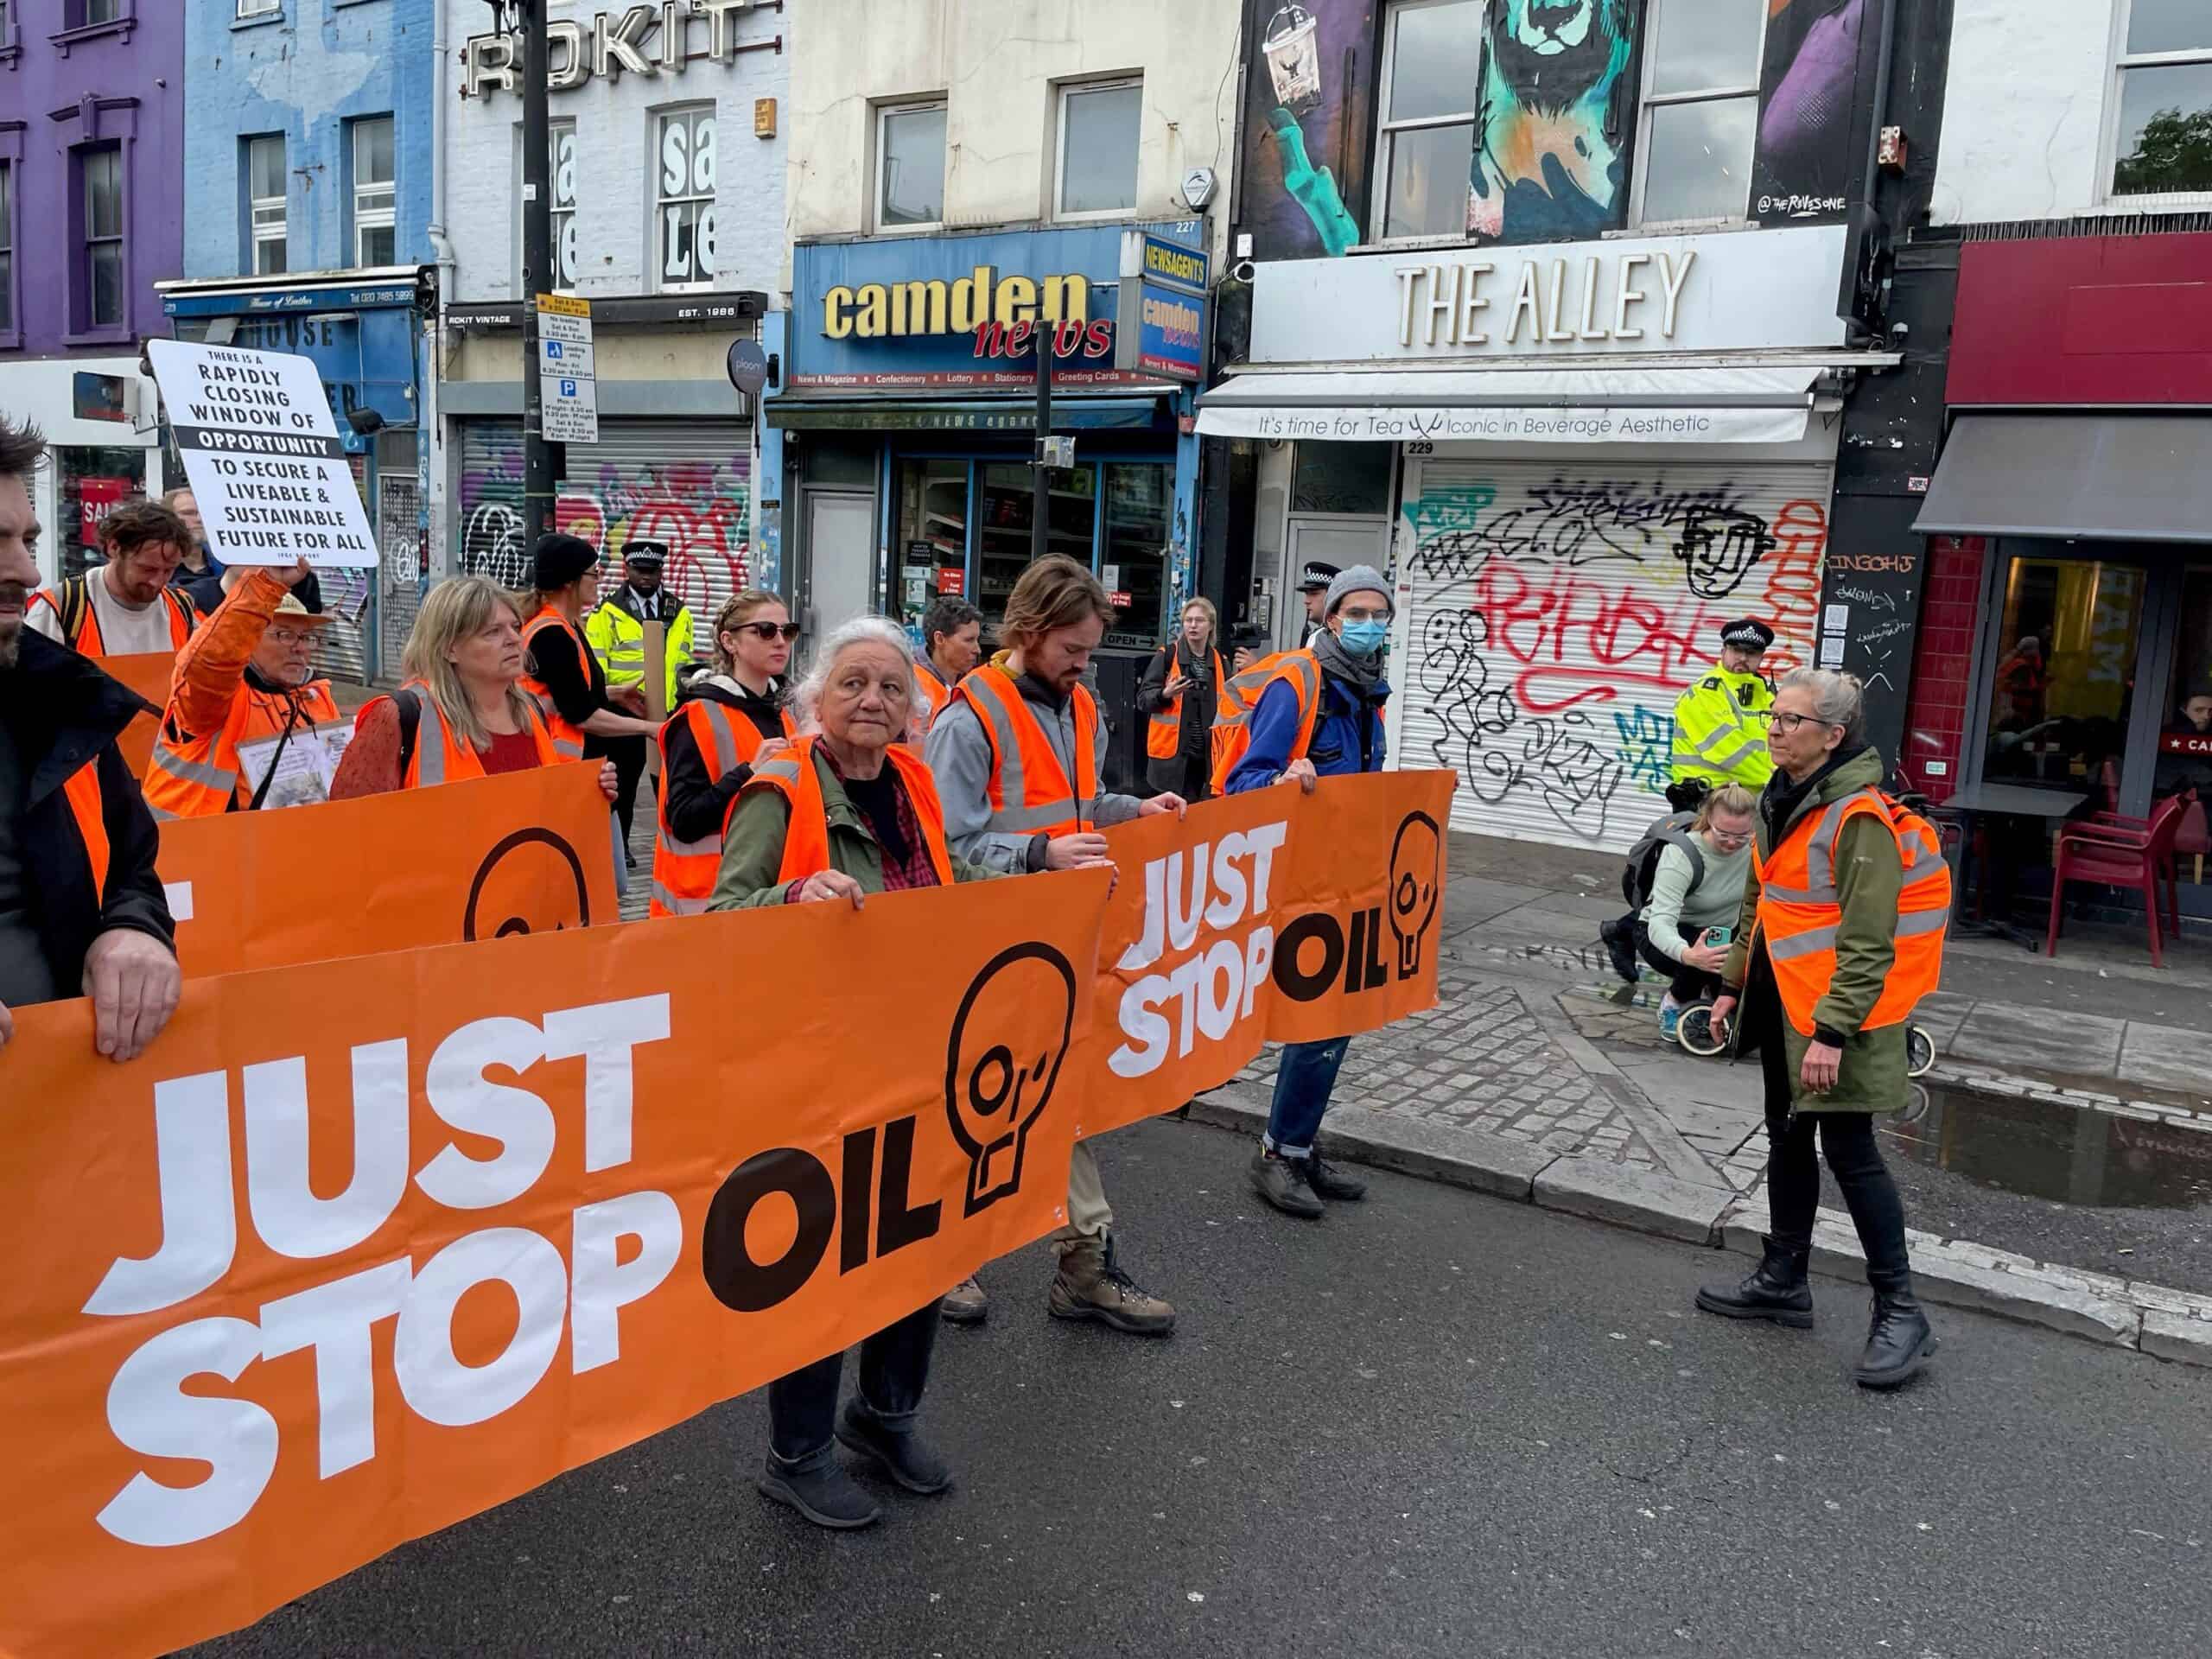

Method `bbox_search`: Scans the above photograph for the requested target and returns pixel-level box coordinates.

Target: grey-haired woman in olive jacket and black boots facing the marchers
[1697,668,1936,1389]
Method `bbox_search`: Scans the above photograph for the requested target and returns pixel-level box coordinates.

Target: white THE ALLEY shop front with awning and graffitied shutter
[1199,226,1897,849]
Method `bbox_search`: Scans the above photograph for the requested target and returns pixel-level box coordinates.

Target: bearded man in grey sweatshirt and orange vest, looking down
[927,553,1184,1336]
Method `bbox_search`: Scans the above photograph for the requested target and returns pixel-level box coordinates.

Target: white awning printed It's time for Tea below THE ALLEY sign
[1199,365,1822,445]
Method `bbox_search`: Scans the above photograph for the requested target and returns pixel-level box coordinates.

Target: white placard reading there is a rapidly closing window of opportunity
[146,340,376,570]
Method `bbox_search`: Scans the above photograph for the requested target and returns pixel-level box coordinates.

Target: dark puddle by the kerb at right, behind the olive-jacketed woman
[1883,1089,2212,1210]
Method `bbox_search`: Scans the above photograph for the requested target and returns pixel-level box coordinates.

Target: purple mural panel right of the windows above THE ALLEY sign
[1752,0,1872,224]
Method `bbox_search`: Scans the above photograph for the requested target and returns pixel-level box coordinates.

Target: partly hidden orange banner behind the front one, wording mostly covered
[155,763,615,978]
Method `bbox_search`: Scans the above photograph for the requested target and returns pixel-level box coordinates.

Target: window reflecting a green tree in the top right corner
[2110,0,2212,199]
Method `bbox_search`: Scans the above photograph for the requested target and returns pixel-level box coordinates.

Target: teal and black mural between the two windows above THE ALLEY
[1466,0,1637,241]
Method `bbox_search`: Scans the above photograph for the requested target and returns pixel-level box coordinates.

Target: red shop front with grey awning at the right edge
[1904,234,2212,916]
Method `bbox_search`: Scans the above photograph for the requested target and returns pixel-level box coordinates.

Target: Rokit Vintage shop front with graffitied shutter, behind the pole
[438,289,774,641]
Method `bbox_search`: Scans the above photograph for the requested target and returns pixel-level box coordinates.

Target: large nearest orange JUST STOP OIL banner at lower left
[0,875,1109,1655]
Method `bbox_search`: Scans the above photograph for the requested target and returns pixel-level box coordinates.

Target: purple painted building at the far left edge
[0,0,183,575]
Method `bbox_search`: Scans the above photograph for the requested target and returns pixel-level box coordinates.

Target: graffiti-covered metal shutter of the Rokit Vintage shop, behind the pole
[458,420,752,668]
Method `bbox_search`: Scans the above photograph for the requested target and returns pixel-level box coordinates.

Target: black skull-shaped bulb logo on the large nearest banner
[944,944,1075,1214]
